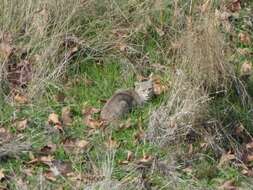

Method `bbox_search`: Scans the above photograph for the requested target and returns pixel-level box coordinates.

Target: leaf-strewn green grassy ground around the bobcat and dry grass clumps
[0,0,253,190]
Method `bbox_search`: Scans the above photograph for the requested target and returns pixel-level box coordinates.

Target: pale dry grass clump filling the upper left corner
[0,0,83,97]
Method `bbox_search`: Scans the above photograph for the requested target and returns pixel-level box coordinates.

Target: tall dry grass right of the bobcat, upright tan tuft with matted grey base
[147,1,237,146]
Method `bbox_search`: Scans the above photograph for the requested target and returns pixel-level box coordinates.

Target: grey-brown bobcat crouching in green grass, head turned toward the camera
[100,80,154,122]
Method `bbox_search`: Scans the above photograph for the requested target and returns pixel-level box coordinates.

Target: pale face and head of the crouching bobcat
[135,80,154,102]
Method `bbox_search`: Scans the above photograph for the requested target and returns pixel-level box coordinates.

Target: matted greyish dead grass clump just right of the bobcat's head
[146,74,209,146]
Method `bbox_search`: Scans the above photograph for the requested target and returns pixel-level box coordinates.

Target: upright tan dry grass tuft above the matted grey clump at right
[176,13,234,92]
